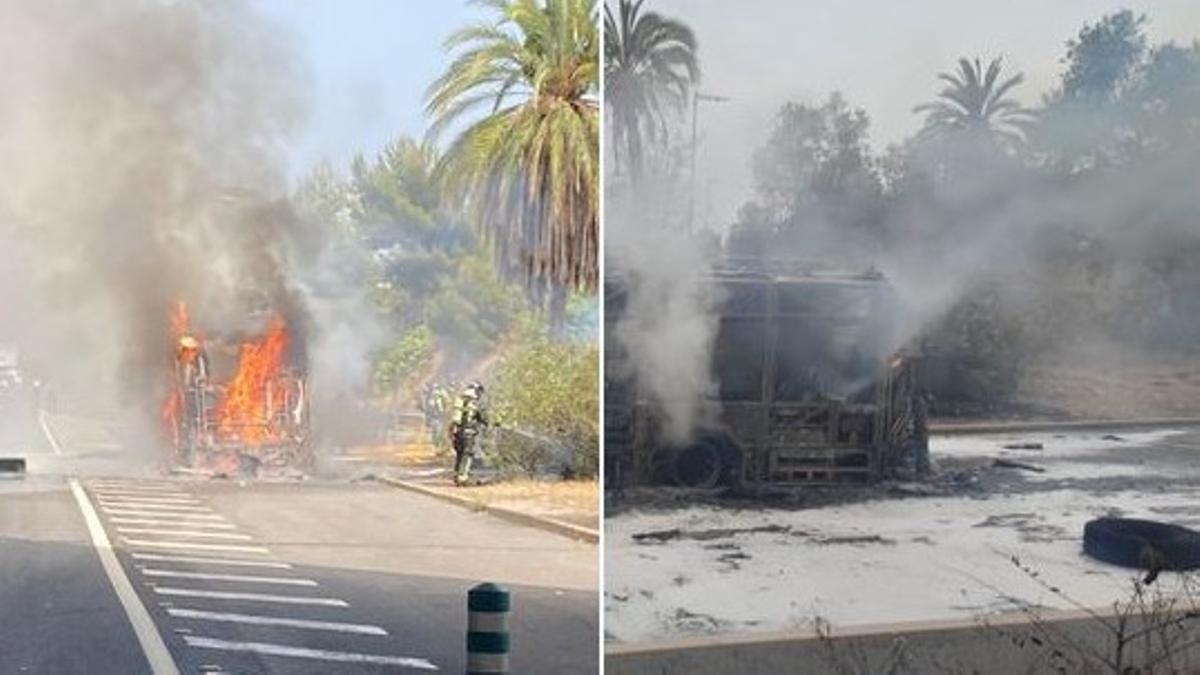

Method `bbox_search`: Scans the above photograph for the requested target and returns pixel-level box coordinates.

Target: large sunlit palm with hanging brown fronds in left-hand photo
[426,0,600,318]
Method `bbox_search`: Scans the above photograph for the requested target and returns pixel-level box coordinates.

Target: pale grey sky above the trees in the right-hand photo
[644,0,1200,229]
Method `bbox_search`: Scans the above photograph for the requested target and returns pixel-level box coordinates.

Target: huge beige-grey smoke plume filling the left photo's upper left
[0,0,331,437]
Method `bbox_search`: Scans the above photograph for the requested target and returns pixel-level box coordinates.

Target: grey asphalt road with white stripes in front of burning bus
[0,417,599,675]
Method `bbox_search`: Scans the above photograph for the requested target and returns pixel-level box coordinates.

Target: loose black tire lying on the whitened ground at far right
[1084,518,1200,571]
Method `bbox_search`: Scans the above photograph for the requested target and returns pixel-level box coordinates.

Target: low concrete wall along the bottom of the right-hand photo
[605,611,1200,675]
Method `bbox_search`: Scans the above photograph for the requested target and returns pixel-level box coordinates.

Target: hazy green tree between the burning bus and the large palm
[296,138,527,390]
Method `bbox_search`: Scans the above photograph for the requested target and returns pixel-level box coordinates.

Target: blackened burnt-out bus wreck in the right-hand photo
[605,263,929,488]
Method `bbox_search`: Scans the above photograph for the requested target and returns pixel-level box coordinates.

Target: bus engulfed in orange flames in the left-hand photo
[162,301,311,476]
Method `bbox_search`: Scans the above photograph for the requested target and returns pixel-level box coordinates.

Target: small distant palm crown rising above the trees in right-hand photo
[913,58,1034,144]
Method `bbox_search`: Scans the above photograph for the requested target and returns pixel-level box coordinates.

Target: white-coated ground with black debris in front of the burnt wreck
[605,429,1200,643]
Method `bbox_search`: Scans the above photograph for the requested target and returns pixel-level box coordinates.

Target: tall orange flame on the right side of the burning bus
[217,316,288,446]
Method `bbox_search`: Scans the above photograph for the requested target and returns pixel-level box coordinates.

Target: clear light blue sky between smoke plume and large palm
[253,0,485,179]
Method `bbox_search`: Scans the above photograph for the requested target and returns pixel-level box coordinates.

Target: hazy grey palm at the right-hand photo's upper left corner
[604,0,700,178]
